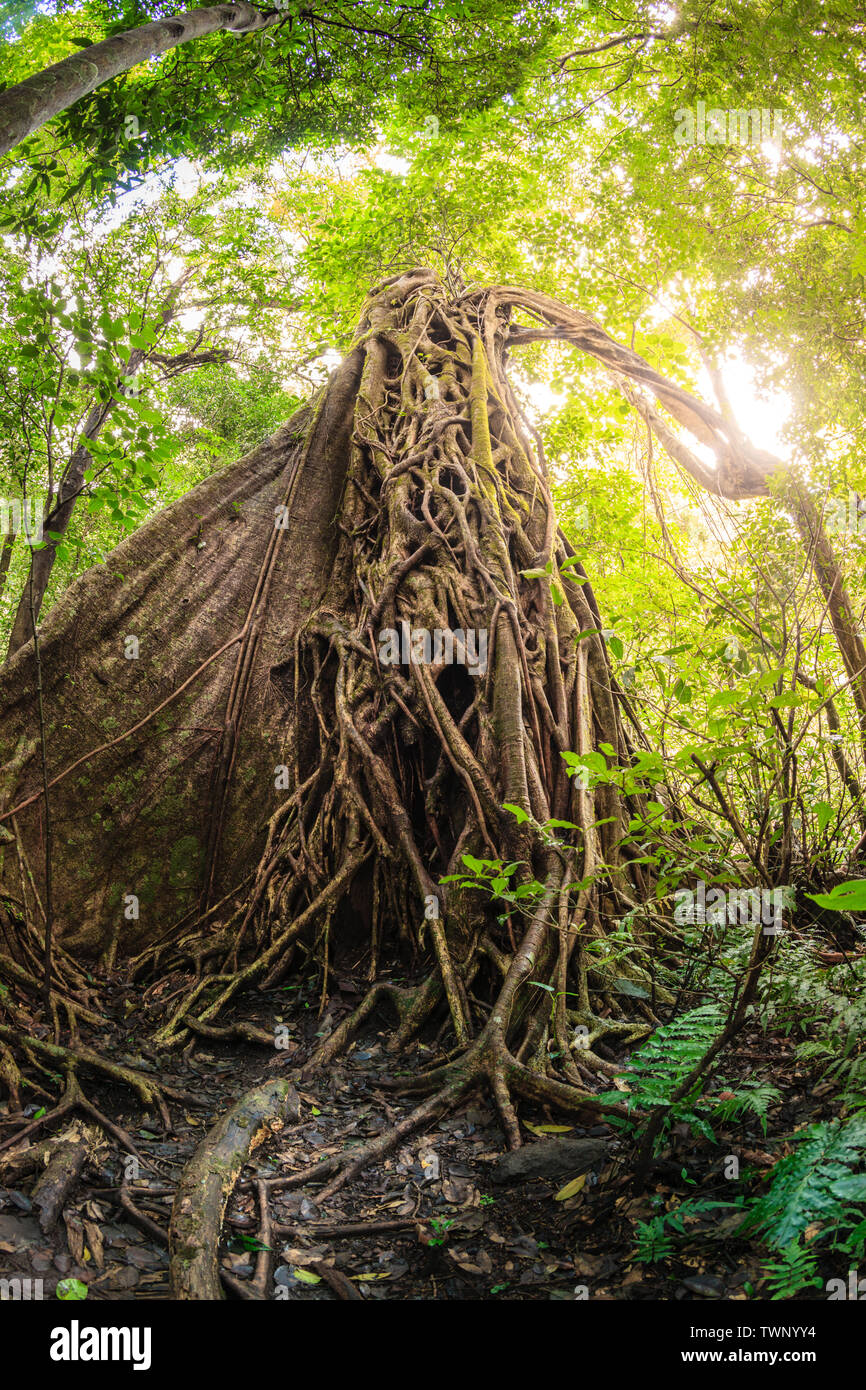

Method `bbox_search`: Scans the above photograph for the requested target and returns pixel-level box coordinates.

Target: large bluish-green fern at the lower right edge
[744,1115,866,1251]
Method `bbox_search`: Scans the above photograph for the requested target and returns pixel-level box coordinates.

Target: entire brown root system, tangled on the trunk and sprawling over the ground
[0,271,748,1298]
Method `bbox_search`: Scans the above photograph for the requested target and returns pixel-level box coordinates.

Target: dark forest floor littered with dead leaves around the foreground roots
[0,976,848,1301]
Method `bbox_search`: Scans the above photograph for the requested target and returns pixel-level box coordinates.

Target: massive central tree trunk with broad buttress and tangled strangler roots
[0,270,839,1128]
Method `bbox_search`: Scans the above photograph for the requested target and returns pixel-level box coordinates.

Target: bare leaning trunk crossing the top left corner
[0,0,284,154]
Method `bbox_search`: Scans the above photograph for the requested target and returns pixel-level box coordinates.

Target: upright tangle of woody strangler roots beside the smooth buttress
[138,271,676,1078]
